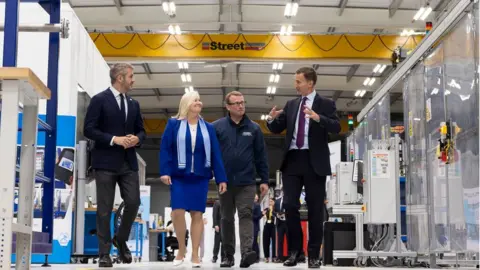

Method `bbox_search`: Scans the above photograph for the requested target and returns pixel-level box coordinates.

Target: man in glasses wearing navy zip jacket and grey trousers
[213,91,269,268]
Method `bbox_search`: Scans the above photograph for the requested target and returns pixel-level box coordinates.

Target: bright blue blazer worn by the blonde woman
[159,118,227,184]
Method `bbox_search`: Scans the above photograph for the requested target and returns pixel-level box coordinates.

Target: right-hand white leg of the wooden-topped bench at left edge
[16,102,38,269]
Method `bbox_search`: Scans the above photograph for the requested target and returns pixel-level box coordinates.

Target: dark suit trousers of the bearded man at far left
[95,162,140,255]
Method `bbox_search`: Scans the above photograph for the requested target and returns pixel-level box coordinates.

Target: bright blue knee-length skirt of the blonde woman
[170,175,210,213]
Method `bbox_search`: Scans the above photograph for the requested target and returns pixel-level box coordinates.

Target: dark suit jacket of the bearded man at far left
[83,88,146,171]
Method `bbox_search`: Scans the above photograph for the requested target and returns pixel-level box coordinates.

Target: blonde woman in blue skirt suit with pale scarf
[160,91,227,267]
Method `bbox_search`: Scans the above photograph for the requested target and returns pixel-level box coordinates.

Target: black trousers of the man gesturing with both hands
[283,150,326,257]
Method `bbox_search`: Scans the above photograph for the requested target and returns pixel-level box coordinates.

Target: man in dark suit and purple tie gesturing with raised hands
[267,67,340,268]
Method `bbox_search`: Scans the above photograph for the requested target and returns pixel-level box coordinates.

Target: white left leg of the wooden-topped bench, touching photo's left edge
[0,80,21,269]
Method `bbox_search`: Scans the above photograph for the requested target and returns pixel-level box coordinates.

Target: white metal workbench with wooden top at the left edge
[0,68,51,269]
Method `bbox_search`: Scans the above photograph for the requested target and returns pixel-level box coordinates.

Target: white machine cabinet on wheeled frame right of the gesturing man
[329,135,416,266]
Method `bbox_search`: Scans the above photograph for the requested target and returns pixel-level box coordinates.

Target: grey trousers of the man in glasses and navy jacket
[220,185,257,256]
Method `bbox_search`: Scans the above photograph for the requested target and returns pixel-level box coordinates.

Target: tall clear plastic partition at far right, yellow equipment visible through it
[404,10,480,254]
